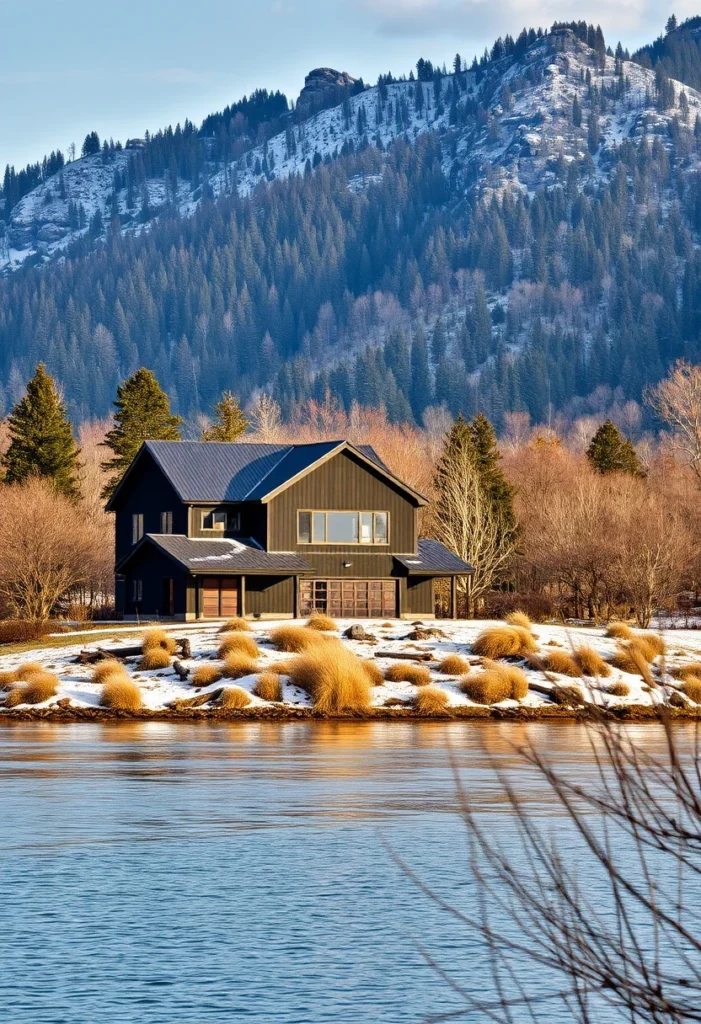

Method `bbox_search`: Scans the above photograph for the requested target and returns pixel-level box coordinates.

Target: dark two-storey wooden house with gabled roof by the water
[107,441,472,620]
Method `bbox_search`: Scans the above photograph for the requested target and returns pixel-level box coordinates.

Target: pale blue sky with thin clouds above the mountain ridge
[0,0,687,172]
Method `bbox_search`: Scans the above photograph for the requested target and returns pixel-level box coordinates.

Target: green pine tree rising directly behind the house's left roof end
[102,367,182,498]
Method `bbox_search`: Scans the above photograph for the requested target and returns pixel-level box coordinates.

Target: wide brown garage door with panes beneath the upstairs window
[300,580,397,618]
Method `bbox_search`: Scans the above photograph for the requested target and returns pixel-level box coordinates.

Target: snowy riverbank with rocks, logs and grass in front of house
[0,620,701,723]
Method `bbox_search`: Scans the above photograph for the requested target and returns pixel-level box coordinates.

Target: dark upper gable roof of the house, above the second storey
[107,440,427,511]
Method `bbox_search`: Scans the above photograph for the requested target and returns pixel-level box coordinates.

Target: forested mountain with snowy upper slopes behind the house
[0,24,701,424]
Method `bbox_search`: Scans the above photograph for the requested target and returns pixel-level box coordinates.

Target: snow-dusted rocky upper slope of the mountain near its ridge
[0,30,701,272]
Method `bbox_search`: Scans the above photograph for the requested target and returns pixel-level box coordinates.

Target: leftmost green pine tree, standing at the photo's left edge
[2,362,80,500]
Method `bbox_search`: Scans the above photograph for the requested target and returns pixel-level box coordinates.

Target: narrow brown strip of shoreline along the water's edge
[0,705,701,725]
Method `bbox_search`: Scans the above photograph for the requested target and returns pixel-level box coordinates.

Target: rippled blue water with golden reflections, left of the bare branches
[0,723,687,1024]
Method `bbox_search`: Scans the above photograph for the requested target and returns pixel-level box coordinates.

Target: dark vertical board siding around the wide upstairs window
[268,452,417,557]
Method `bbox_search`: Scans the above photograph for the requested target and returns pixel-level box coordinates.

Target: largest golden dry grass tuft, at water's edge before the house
[290,646,370,714]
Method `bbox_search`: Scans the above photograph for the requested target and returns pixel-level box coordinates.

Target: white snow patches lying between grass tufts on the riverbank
[0,620,701,710]
